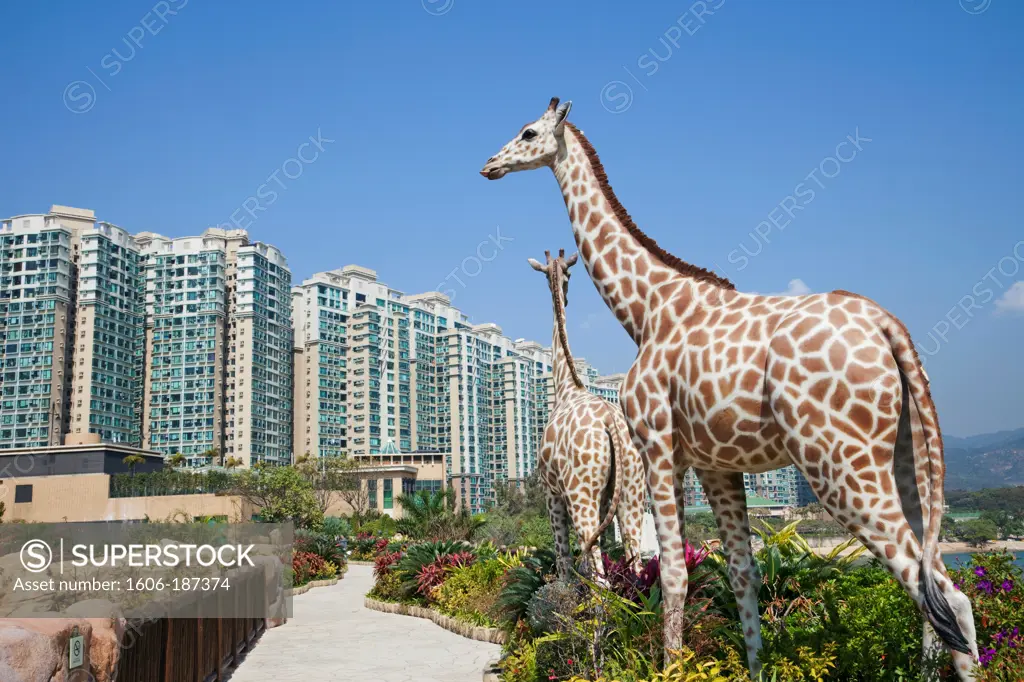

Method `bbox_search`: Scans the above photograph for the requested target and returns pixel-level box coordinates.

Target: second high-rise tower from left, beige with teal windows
[135,227,293,466]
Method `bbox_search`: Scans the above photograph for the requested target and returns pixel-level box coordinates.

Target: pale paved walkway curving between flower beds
[229,566,501,682]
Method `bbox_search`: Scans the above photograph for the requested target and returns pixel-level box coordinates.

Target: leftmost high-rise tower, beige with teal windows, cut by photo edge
[0,206,149,449]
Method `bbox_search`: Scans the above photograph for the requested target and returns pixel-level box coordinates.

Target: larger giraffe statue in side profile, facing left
[480,98,978,680]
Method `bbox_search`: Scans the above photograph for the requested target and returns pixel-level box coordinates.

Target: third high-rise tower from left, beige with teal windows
[293,265,467,457]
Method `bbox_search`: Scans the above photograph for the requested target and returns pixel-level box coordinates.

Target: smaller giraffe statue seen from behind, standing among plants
[529,249,647,576]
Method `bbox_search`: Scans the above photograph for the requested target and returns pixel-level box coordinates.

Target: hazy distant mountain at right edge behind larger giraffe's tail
[943,429,1024,491]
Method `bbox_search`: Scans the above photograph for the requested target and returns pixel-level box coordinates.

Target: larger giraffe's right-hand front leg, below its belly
[696,470,761,680]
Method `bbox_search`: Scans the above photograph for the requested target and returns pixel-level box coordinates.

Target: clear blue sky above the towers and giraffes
[0,0,1024,435]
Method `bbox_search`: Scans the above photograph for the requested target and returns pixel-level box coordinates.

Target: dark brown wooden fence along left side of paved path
[114,571,266,682]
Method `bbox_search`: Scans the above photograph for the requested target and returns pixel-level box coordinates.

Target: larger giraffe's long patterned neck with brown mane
[553,123,733,344]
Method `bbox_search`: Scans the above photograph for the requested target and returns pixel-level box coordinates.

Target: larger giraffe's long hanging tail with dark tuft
[882,315,972,654]
